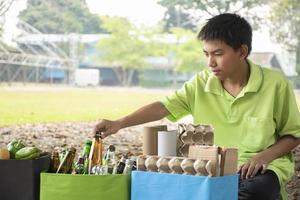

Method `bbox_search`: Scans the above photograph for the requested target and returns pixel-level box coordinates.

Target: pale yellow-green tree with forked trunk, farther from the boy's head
[97,17,149,85]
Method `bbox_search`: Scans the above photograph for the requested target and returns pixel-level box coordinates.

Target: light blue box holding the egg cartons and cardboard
[131,171,238,200]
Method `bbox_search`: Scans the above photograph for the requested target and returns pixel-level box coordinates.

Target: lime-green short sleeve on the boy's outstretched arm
[161,76,197,122]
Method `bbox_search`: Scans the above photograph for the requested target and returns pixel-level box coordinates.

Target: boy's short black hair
[197,13,252,56]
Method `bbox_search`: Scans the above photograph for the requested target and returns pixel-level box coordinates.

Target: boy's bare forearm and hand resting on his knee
[239,135,300,179]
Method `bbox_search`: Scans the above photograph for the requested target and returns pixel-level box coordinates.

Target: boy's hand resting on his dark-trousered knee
[238,154,268,179]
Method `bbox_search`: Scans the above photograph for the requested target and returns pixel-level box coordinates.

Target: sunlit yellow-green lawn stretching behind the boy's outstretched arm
[0,87,170,127]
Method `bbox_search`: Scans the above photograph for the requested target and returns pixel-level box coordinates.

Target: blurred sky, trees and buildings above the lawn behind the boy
[0,0,300,88]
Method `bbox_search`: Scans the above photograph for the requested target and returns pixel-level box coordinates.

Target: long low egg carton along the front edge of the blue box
[137,155,213,176]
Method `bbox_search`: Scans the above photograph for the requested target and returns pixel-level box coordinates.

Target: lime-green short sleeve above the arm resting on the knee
[275,81,300,138]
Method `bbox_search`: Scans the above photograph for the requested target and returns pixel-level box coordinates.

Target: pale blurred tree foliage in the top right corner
[269,0,300,87]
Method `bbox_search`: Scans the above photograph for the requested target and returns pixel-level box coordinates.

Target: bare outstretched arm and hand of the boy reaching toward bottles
[94,101,169,138]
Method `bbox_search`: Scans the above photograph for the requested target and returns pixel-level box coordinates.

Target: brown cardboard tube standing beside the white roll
[143,125,167,155]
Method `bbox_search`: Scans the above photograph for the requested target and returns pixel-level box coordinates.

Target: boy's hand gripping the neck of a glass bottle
[94,119,121,139]
